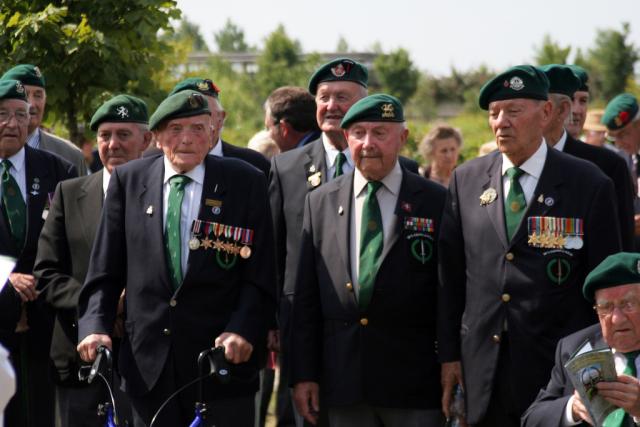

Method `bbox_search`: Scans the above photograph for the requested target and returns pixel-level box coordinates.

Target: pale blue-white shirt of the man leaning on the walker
[162,157,205,277]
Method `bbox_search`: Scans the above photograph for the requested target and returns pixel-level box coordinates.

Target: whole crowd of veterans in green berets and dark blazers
[0,58,640,427]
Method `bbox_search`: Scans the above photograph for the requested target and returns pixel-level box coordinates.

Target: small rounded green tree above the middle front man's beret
[373,48,420,103]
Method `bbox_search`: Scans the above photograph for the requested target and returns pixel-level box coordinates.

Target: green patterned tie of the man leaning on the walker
[164,175,191,289]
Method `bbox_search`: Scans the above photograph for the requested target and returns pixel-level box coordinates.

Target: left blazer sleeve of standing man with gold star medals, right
[437,171,466,362]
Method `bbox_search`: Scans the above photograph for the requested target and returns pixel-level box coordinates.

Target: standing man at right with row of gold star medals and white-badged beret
[438,65,621,426]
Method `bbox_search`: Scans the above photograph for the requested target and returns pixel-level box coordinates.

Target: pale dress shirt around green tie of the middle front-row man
[349,160,402,295]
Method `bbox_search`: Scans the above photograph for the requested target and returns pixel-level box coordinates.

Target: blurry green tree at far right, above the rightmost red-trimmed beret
[587,23,638,100]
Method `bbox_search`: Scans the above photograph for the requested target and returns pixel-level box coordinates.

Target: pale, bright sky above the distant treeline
[178,0,640,75]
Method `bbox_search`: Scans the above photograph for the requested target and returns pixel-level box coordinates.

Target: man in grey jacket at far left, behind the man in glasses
[0,64,87,176]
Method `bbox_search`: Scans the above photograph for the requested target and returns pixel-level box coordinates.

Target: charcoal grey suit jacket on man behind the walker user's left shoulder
[34,170,104,383]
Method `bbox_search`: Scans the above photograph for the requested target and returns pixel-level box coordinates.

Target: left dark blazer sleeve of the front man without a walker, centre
[284,193,323,386]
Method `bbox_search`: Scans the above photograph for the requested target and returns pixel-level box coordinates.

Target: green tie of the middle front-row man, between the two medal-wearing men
[358,181,384,310]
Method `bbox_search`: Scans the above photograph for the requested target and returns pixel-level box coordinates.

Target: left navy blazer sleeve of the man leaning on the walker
[78,169,127,341]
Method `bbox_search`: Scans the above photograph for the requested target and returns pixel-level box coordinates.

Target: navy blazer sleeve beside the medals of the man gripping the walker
[225,174,276,345]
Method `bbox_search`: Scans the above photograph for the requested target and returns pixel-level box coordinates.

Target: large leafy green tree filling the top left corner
[0,0,180,144]
